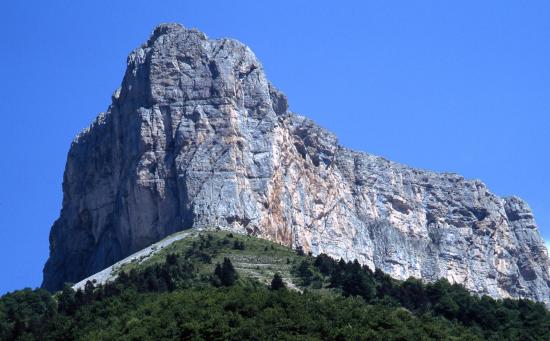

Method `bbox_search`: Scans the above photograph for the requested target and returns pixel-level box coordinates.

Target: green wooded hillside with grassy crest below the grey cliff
[0,231,550,340]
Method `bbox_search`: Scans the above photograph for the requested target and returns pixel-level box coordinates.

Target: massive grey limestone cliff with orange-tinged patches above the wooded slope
[43,24,550,302]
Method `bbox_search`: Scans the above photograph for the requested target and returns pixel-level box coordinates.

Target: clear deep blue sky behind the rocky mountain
[0,0,550,293]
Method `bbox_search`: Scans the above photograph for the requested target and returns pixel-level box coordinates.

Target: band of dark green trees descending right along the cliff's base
[304,254,550,340]
